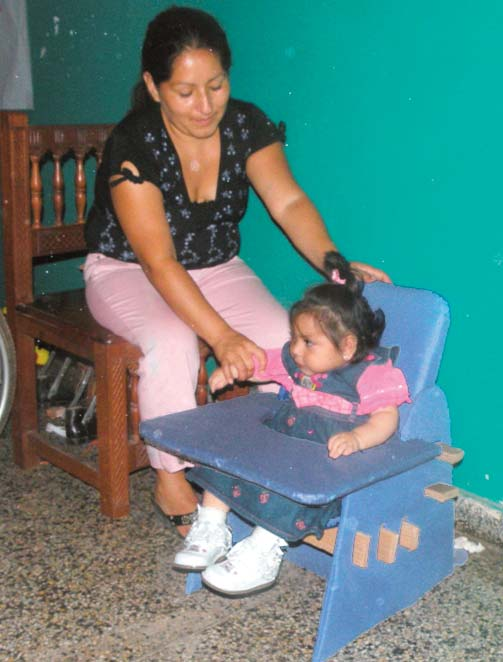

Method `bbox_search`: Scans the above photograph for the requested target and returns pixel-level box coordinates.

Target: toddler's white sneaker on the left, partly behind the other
[173,517,232,571]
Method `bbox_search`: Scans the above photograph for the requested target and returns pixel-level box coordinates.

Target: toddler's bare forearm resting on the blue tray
[328,406,398,459]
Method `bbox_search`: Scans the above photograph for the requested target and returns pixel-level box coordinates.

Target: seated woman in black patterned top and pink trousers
[84,7,387,535]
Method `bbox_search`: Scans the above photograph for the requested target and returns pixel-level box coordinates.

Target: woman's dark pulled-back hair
[132,5,231,110]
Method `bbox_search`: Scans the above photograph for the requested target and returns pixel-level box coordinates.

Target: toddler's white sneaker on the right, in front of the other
[201,529,287,595]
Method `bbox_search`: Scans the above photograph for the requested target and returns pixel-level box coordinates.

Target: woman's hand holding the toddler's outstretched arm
[212,329,267,390]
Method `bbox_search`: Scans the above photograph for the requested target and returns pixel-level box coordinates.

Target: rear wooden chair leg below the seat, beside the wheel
[12,333,40,469]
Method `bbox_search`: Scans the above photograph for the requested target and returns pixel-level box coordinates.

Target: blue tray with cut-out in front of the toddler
[140,393,440,505]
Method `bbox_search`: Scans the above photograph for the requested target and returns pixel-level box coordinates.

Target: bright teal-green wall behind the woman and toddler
[22,0,503,503]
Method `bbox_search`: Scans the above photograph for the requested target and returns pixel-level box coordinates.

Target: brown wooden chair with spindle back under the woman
[0,112,238,517]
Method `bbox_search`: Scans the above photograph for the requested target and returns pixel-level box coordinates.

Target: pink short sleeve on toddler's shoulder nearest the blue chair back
[356,360,410,414]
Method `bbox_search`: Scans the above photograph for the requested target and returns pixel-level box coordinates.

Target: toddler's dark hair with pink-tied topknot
[290,251,385,363]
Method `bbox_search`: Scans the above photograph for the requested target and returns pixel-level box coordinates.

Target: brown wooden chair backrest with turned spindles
[0,112,112,318]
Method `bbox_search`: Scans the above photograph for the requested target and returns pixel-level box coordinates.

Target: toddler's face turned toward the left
[290,313,348,377]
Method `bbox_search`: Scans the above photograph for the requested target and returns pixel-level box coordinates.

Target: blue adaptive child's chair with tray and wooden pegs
[141,283,462,661]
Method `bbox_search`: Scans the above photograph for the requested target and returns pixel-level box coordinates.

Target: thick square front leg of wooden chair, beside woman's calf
[95,344,129,517]
